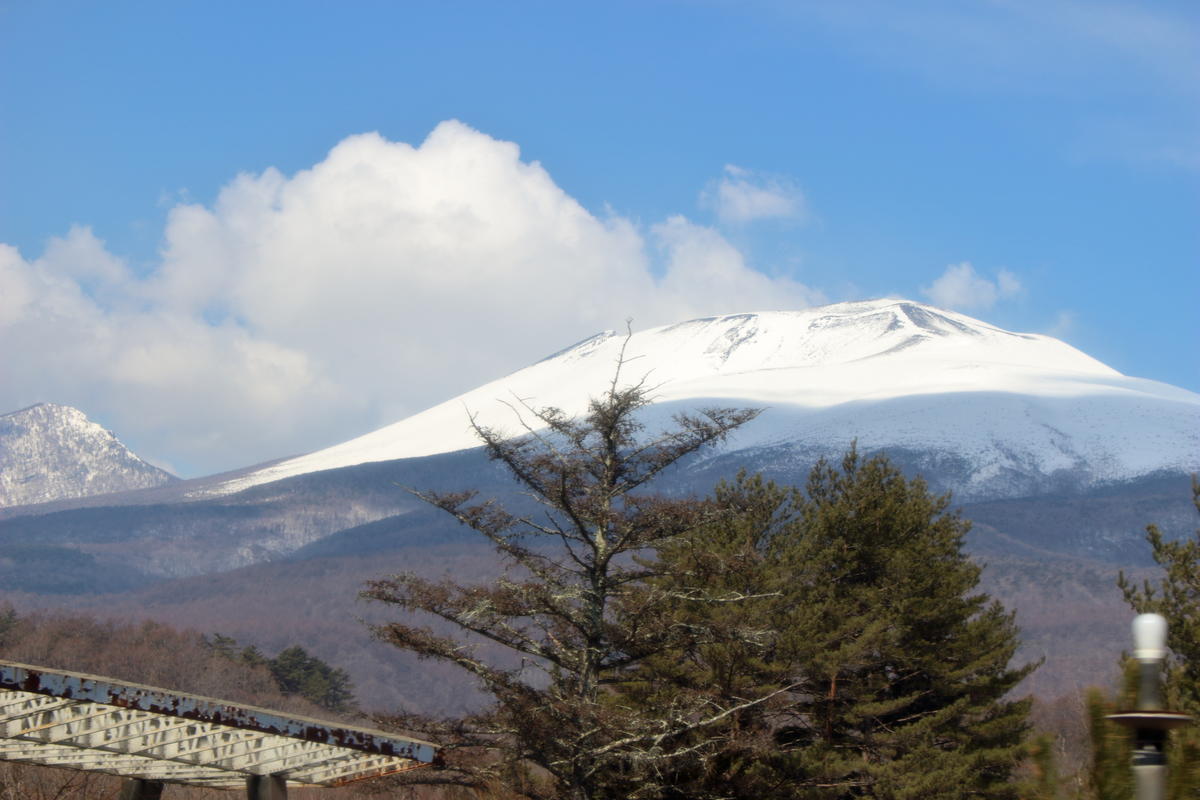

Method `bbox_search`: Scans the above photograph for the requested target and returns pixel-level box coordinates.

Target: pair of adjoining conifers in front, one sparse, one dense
[364,371,1036,800]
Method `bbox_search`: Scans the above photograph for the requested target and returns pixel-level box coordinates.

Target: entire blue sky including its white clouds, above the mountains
[0,0,1200,475]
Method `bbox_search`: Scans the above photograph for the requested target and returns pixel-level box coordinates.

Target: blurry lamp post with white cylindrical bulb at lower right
[1109,614,1192,800]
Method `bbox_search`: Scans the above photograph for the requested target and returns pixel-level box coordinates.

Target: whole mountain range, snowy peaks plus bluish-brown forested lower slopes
[0,300,1200,710]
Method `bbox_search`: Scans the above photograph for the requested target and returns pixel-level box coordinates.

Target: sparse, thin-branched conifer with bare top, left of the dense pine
[362,362,757,800]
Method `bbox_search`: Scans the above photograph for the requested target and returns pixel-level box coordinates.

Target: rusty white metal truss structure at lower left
[0,661,438,798]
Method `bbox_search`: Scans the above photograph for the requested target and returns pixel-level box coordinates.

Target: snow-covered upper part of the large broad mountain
[216,300,1200,499]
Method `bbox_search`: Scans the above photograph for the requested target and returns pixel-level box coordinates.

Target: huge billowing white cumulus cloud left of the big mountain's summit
[0,121,821,473]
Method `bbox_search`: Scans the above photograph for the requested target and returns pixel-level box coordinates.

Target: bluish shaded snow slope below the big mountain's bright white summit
[662,392,1200,503]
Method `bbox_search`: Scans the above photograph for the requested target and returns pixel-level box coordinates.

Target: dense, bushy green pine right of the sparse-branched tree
[622,449,1033,800]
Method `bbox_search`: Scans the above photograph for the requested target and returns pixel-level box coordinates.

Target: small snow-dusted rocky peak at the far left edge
[0,403,175,507]
